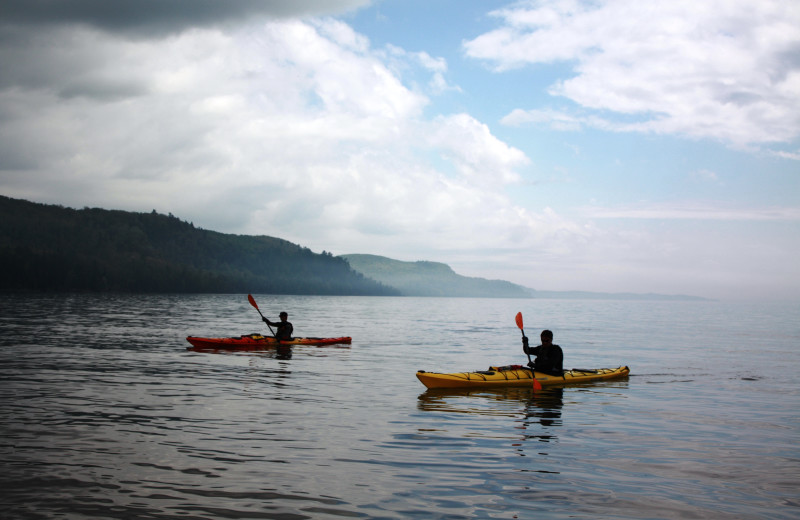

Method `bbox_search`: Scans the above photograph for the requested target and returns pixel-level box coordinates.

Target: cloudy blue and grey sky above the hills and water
[0,0,800,301]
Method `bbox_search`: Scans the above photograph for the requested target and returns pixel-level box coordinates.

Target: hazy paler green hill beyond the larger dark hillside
[342,255,531,298]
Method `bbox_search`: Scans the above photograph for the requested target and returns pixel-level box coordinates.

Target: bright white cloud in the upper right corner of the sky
[464,0,800,147]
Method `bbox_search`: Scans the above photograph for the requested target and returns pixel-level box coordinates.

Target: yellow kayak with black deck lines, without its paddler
[417,365,630,388]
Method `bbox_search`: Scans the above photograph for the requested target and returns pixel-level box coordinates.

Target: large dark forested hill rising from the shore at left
[0,196,399,295]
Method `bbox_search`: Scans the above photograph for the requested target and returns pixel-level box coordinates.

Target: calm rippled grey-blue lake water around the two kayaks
[0,295,800,520]
